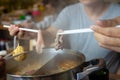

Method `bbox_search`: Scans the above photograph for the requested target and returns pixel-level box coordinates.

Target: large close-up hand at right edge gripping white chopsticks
[91,17,120,52]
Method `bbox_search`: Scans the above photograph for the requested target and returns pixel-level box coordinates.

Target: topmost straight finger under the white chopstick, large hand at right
[91,25,120,38]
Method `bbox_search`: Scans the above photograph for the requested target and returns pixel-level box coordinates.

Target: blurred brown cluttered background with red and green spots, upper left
[0,0,78,50]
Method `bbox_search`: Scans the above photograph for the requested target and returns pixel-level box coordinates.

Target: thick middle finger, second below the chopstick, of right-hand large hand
[95,33,120,46]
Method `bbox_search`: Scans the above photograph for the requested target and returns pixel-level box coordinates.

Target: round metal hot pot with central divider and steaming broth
[6,48,108,80]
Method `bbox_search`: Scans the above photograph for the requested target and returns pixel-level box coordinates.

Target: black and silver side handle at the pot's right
[73,59,106,80]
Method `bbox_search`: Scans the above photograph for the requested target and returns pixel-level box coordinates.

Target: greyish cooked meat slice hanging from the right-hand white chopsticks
[55,30,63,50]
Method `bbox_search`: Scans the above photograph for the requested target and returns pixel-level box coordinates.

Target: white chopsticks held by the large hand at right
[57,25,120,35]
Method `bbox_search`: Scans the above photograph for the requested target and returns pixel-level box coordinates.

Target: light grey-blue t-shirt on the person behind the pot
[52,3,120,60]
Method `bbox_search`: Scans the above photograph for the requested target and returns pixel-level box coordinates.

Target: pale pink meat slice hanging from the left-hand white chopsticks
[36,30,45,53]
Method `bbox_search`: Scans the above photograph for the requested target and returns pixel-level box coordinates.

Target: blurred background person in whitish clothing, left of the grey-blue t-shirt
[23,0,74,29]
